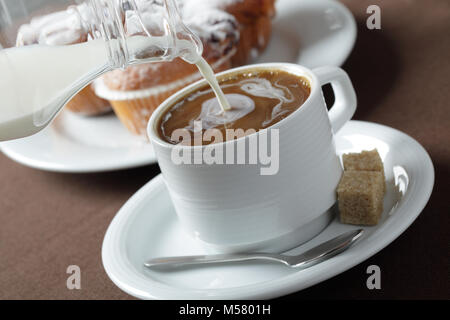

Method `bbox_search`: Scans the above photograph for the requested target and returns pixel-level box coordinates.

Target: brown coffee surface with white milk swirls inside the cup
[158,70,311,145]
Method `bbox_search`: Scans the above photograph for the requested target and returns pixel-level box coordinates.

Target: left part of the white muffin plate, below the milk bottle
[0,111,156,173]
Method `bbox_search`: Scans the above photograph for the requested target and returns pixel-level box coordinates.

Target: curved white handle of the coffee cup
[313,66,356,132]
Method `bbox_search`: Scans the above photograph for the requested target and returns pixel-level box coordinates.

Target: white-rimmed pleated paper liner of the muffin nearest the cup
[94,59,231,137]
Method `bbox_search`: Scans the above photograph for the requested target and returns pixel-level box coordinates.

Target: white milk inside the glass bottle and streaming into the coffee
[0,36,230,140]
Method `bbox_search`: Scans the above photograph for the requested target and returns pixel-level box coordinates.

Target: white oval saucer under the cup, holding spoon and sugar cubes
[102,121,434,299]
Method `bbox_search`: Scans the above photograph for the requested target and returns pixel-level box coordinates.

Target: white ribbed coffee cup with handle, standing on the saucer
[147,63,356,252]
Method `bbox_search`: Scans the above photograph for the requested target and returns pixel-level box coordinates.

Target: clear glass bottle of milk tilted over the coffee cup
[0,0,203,141]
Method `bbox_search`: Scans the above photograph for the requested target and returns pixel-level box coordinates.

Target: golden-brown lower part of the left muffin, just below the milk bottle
[66,85,111,116]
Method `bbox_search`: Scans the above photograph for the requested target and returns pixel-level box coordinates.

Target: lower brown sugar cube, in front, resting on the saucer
[337,171,384,226]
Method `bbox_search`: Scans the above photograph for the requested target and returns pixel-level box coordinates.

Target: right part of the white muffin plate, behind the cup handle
[257,0,357,69]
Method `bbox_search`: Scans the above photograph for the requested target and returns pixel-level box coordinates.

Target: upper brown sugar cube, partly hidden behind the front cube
[342,149,386,193]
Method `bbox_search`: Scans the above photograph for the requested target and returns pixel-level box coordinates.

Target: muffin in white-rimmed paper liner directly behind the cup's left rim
[95,56,231,136]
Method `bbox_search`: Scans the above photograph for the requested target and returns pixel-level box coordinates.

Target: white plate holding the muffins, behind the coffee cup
[0,0,356,173]
